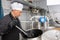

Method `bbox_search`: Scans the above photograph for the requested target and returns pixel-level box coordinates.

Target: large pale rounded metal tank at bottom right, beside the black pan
[41,30,60,40]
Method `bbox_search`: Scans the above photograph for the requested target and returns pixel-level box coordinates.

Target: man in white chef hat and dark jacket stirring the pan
[0,2,23,40]
